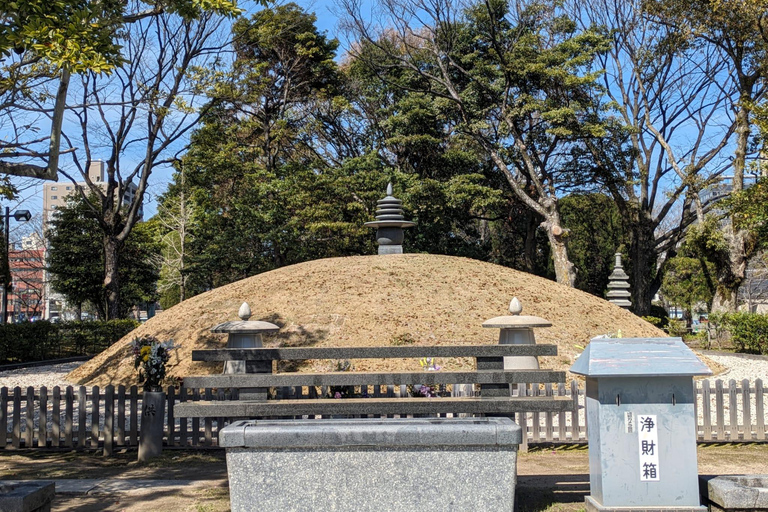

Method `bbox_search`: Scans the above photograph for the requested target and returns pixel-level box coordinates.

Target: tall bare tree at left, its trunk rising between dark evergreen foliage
[50,14,230,318]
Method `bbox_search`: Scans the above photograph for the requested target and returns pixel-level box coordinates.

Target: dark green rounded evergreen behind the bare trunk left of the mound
[48,196,159,318]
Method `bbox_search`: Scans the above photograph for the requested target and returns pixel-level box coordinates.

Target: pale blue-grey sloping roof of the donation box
[571,338,712,377]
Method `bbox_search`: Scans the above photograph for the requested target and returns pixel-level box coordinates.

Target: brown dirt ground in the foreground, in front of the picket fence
[0,443,768,512]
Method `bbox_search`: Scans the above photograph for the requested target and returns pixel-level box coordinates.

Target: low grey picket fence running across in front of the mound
[0,379,768,455]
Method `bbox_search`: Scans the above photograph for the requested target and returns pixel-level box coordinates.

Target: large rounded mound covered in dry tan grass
[67,254,665,386]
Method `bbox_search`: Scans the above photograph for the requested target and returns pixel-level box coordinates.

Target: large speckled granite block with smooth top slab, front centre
[219,418,521,512]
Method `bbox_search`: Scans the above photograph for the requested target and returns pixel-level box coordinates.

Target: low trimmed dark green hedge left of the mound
[0,320,139,364]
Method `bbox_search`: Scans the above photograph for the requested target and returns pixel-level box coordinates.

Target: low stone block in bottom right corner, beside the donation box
[699,475,768,512]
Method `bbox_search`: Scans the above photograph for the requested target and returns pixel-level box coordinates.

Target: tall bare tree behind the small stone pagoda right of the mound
[569,0,735,315]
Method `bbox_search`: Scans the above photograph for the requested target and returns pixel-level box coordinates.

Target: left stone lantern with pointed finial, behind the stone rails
[211,302,280,400]
